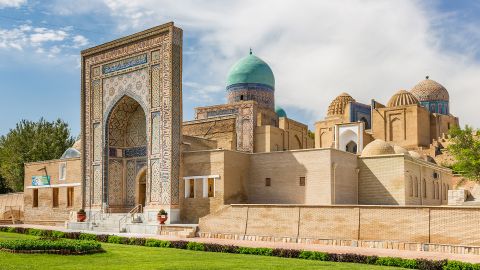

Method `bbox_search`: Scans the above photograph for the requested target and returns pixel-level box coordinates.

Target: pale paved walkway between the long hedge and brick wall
[9,224,480,263]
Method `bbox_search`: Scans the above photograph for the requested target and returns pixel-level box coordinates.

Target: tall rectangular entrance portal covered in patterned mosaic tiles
[81,23,182,223]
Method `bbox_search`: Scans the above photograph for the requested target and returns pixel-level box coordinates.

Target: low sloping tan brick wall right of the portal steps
[199,205,480,246]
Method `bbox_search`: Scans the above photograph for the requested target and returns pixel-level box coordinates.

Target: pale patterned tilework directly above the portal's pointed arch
[103,68,150,114]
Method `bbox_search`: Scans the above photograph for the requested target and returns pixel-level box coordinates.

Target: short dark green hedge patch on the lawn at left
[0,238,103,254]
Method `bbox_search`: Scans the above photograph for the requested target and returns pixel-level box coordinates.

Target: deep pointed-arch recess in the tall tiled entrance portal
[104,96,147,212]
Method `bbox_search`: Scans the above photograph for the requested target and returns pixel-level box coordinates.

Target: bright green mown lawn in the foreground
[0,232,404,270]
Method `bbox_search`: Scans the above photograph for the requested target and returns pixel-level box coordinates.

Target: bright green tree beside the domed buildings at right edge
[447,126,480,182]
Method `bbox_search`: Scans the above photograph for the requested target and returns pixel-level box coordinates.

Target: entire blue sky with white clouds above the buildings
[0,0,480,136]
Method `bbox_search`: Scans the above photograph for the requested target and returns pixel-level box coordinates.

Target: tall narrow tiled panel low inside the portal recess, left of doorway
[108,159,123,205]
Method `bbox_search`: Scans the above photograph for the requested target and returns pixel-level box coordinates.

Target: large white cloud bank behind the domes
[52,0,480,127]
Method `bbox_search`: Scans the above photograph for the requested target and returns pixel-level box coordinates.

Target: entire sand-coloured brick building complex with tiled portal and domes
[25,23,458,226]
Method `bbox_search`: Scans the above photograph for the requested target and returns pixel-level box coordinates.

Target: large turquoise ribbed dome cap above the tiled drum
[227,53,275,89]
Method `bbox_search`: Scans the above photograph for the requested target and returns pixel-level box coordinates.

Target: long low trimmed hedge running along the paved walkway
[0,226,480,270]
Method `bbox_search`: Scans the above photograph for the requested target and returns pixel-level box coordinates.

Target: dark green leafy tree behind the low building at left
[0,118,75,191]
